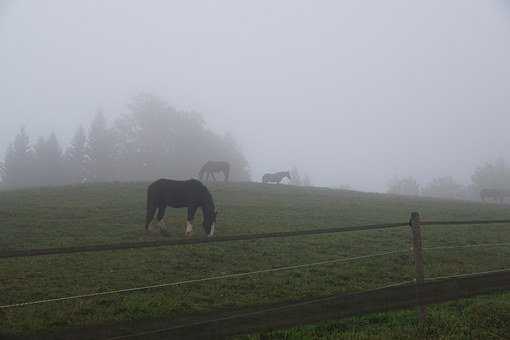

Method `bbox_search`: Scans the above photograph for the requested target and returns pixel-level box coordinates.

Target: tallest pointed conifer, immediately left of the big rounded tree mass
[86,111,115,182]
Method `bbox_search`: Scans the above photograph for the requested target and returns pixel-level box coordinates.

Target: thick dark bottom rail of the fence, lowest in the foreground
[49,269,510,340]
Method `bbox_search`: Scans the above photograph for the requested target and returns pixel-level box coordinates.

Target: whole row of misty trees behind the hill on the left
[0,94,250,188]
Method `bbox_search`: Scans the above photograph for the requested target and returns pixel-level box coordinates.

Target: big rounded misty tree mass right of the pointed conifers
[115,94,249,181]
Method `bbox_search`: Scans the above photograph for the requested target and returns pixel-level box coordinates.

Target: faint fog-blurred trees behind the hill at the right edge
[387,159,510,200]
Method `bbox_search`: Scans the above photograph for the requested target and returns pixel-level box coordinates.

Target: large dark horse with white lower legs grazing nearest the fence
[145,179,217,236]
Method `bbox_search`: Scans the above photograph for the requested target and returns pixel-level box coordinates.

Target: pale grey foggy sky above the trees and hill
[0,0,510,191]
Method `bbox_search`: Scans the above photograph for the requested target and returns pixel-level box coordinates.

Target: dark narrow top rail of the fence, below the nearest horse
[0,220,510,259]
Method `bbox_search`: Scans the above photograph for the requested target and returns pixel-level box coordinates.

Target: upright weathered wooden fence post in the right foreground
[409,212,427,321]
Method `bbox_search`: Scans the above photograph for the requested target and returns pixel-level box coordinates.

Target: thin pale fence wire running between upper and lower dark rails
[0,242,510,309]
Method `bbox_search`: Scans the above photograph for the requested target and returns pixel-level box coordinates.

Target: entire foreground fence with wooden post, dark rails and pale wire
[0,213,510,339]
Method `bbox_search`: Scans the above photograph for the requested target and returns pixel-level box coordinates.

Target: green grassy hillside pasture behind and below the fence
[0,183,510,339]
